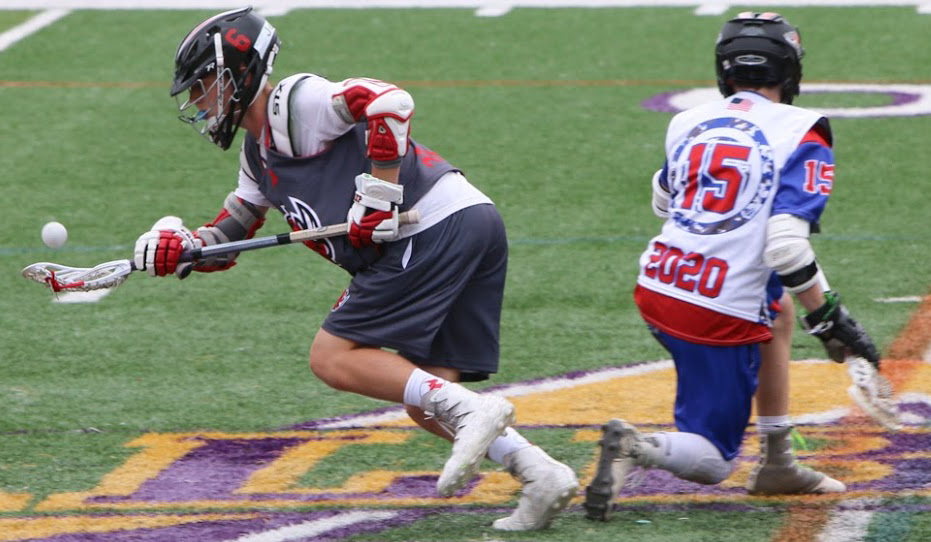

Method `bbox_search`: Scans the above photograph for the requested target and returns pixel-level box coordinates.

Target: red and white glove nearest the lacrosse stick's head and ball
[133,216,203,279]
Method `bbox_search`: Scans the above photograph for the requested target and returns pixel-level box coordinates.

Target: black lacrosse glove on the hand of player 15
[799,292,879,370]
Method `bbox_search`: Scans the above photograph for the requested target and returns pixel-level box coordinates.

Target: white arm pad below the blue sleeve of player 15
[763,214,827,294]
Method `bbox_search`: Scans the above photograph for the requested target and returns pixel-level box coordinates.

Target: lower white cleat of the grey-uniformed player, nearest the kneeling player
[491,446,579,531]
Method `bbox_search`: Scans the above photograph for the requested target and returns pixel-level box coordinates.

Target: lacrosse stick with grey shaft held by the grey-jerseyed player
[23,209,420,292]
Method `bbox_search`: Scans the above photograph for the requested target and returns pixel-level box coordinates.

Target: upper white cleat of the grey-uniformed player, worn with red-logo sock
[423,383,515,497]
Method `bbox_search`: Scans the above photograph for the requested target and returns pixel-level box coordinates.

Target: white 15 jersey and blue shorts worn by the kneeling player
[634,91,834,460]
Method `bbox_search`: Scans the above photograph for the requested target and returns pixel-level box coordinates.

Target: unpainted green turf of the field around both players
[0,7,931,540]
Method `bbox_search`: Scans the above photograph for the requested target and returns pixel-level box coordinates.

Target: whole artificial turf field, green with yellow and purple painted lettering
[0,5,931,542]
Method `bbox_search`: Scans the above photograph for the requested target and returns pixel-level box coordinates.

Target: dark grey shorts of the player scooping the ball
[323,204,508,381]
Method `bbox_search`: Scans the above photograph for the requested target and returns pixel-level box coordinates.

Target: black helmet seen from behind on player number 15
[714,11,805,104]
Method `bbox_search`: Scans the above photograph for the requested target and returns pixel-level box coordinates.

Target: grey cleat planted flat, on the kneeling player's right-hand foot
[747,427,847,495]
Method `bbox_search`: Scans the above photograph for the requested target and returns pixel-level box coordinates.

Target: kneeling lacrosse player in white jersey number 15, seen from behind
[584,12,879,520]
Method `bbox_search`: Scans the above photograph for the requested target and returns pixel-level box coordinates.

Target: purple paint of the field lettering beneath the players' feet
[12,362,931,542]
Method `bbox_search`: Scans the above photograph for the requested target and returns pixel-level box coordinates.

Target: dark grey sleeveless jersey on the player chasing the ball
[243,123,458,275]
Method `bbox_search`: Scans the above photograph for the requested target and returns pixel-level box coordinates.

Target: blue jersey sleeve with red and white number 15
[772,142,834,224]
